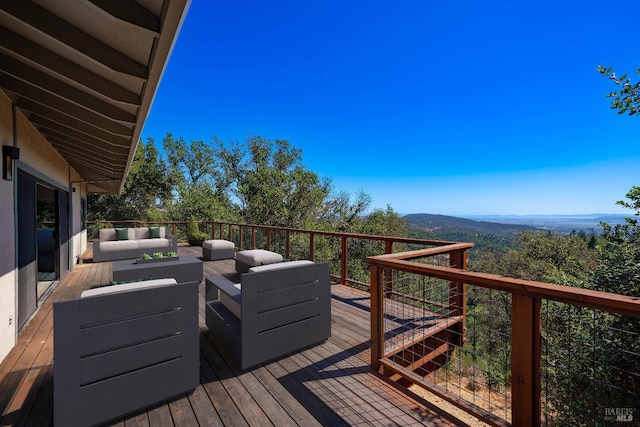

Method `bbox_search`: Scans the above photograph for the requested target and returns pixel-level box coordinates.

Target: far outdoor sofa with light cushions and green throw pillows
[93,227,178,262]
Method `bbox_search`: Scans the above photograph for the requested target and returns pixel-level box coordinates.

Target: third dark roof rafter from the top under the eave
[0,27,141,106]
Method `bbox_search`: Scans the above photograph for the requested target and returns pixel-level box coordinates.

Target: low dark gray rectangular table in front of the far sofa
[112,255,202,283]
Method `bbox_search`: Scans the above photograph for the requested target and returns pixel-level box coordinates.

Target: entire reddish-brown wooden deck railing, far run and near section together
[89,221,640,426]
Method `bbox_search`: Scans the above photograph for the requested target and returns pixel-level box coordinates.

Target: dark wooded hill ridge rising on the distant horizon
[403,214,536,257]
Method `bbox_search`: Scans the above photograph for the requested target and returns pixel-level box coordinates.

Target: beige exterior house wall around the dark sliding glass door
[0,91,87,362]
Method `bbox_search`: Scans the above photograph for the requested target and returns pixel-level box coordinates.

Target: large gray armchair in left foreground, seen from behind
[53,279,200,426]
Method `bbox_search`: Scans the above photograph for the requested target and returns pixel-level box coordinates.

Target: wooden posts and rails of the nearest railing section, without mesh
[368,249,640,426]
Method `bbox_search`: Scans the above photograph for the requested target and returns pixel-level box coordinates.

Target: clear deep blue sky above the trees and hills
[142,0,640,215]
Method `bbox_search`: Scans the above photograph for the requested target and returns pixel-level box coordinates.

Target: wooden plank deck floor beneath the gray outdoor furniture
[0,247,464,427]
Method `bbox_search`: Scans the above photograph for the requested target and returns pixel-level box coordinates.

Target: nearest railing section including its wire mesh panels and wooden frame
[368,246,640,426]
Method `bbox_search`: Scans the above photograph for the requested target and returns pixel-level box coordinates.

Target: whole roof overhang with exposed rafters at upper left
[0,0,190,192]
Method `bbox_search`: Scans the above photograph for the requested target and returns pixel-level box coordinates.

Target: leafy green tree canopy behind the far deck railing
[88,133,390,234]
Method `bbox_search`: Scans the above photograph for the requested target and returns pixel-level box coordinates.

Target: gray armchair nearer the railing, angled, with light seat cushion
[206,261,331,369]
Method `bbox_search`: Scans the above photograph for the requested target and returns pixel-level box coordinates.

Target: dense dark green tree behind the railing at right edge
[545,192,640,425]
